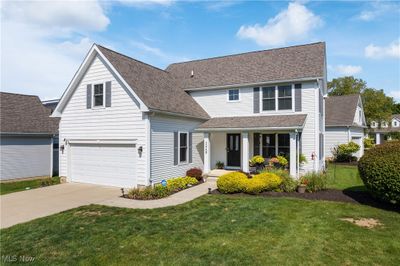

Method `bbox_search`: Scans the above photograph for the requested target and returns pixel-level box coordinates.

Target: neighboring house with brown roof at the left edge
[0,92,59,181]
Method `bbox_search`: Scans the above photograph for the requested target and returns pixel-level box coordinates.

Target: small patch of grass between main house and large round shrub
[327,164,365,190]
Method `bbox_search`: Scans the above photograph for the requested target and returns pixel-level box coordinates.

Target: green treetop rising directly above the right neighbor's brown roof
[328,76,367,96]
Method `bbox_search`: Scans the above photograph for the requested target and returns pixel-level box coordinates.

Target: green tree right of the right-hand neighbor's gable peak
[361,88,394,124]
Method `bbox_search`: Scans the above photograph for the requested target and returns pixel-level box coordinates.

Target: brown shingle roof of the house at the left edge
[0,92,60,134]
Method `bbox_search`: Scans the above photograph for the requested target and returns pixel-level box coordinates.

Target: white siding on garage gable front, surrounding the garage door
[60,57,148,185]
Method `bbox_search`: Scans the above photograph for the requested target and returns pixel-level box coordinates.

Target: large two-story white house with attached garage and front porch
[52,43,327,187]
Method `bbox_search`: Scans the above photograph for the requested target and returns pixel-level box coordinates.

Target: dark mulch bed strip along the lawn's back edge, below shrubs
[211,189,400,212]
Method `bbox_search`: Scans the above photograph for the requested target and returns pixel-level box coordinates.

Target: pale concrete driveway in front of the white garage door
[0,183,121,228]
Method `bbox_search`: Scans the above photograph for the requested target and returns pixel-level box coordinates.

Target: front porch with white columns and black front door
[204,130,300,178]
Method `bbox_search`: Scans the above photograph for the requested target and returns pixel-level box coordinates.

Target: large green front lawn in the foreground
[0,195,400,265]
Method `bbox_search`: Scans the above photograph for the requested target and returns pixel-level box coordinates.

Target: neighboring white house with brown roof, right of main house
[325,94,367,158]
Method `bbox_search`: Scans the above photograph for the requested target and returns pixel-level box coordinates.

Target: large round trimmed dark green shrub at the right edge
[358,141,400,204]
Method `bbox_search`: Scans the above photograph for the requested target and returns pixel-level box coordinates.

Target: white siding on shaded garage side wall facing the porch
[150,114,204,183]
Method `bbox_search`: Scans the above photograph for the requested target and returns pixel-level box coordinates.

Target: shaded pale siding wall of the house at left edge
[0,136,53,180]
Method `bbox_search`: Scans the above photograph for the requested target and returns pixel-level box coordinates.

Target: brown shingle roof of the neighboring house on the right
[325,94,360,126]
